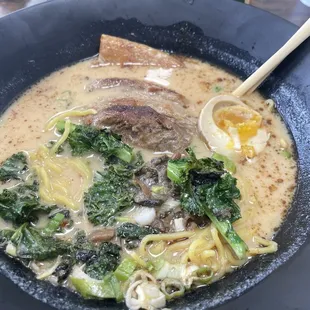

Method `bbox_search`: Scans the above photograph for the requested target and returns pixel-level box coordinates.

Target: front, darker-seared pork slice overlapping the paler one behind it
[85,104,194,153]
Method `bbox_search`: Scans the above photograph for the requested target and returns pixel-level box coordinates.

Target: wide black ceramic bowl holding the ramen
[0,0,310,310]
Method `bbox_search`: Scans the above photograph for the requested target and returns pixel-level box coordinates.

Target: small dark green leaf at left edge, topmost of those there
[0,152,28,182]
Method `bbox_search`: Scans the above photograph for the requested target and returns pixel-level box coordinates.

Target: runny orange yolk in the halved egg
[214,106,262,158]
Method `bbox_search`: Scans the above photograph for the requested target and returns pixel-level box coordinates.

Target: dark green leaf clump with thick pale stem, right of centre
[167,149,247,259]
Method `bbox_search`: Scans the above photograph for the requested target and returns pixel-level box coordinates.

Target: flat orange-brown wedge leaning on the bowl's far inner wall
[99,34,184,68]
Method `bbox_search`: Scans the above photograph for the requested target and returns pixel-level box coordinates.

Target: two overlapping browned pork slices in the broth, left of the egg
[84,78,197,152]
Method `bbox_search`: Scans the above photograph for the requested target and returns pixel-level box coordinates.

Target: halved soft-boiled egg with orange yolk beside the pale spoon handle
[198,95,270,158]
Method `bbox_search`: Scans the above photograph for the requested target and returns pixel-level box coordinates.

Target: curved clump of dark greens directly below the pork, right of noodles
[57,121,143,225]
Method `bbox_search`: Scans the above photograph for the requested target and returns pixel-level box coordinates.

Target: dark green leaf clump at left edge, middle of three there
[0,182,54,226]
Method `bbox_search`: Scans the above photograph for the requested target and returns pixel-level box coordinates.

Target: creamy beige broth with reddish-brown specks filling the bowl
[0,54,297,306]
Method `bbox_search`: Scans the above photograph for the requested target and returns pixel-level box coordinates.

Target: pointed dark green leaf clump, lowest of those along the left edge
[11,223,70,261]
